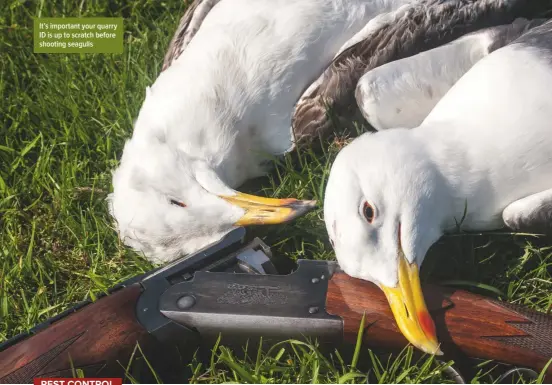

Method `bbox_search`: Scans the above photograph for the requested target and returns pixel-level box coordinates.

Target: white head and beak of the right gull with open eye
[324,129,447,354]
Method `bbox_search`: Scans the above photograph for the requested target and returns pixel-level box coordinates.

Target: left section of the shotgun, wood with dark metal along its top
[0,228,249,383]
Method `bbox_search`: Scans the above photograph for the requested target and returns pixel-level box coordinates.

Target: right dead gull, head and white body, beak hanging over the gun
[324,20,552,354]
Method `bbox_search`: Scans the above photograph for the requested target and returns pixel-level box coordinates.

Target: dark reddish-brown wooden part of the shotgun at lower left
[0,284,152,383]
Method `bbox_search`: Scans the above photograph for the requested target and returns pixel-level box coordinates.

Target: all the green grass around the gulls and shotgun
[0,0,552,383]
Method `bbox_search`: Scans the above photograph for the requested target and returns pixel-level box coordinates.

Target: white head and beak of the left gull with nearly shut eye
[108,138,315,263]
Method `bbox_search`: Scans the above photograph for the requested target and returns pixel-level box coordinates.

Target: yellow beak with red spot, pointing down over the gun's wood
[381,251,443,355]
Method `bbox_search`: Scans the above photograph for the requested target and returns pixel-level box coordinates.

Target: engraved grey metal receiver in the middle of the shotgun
[159,260,343,342]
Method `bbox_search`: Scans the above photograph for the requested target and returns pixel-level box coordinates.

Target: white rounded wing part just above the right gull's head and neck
[355,19,546,130]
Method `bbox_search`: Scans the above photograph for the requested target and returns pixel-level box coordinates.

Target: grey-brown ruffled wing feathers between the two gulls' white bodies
[292,0,549,145]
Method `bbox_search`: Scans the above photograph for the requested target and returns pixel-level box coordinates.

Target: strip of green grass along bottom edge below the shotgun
[181,340,462,384]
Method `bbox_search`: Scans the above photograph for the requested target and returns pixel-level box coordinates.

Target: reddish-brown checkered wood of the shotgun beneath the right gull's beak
[326,273,552,375]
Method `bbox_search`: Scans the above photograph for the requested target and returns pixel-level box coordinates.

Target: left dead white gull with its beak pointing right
[108,0,420,262]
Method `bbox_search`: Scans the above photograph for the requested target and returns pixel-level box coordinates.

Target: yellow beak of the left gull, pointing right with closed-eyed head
[221,192,316,226]
